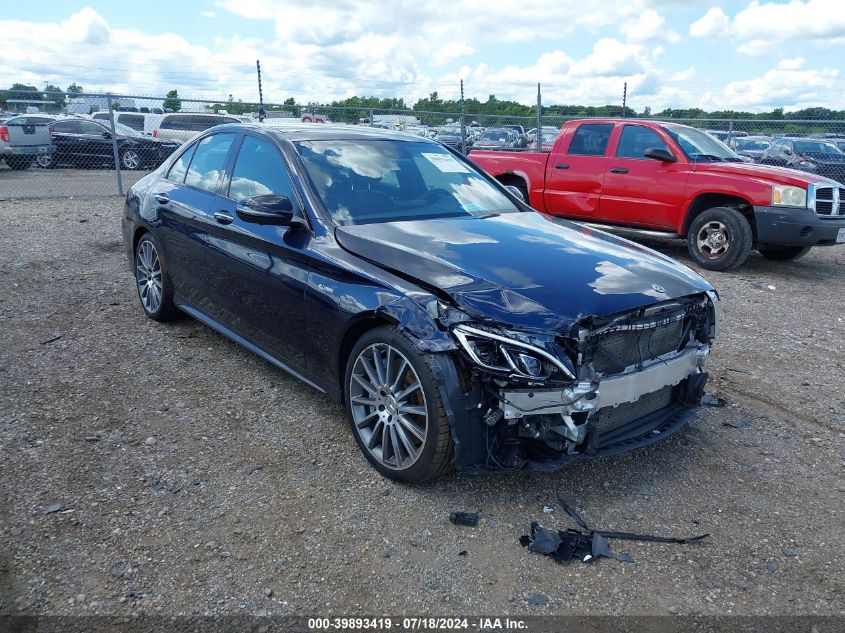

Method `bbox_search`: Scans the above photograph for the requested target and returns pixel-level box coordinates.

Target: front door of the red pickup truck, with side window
[599,124,689,230]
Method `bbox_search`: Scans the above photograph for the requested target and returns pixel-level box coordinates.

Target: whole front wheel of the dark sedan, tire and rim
[344,326,453,483]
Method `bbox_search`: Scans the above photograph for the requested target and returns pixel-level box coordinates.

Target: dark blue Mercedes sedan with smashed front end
[123,125,719,481]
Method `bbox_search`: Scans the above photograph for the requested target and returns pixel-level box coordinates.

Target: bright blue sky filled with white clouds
[0,0,845,112]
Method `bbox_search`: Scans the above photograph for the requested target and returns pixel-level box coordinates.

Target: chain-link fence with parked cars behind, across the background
[0,93,845,200]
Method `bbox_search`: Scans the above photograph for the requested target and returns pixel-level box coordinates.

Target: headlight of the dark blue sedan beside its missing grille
[452,324,575,380]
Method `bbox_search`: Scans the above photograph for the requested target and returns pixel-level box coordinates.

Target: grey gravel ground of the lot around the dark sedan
[0,198,845,615]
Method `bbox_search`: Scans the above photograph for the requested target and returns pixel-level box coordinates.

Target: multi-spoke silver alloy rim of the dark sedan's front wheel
[348,343,429,470]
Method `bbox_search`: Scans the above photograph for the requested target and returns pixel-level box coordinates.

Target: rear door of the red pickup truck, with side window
[543,123,613,220]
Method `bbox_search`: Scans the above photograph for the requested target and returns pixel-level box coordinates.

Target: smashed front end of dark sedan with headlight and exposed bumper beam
[442,292,719,472]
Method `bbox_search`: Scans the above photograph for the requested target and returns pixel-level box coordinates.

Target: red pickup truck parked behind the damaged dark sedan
[469,119,845,270]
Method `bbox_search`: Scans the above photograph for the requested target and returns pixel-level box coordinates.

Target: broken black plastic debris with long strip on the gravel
[519,521,710,564]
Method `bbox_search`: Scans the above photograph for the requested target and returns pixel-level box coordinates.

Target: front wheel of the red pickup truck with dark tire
[687,207,754,270]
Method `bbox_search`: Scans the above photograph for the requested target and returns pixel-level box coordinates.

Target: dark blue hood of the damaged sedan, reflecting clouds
[335,212,711,334]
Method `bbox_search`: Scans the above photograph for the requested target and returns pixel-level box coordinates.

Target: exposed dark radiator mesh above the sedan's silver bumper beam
[593,320,684,374]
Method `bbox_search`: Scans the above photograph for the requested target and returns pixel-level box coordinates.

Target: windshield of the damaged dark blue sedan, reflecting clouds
[296,140,519,225]
